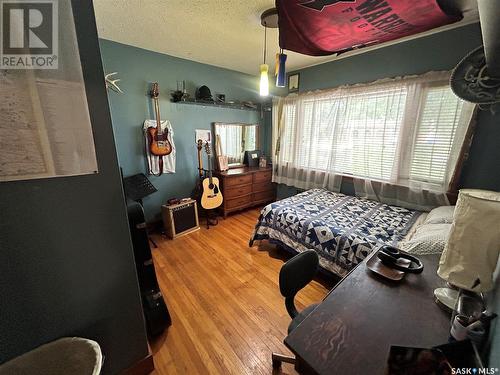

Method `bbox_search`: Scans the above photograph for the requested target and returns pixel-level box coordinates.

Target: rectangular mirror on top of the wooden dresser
[214,122,259,168]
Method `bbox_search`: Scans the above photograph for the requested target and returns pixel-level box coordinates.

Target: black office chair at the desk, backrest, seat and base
[272,250,319,368]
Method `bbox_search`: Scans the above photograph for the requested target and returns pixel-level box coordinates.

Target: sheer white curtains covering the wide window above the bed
[273,72,474,209]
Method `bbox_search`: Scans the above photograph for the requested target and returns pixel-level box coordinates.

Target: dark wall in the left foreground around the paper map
[0,0,148,375]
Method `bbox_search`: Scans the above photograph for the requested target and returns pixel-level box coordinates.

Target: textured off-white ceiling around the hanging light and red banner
[94,0,477,74]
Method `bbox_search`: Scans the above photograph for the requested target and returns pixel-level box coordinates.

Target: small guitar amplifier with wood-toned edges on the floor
[161,199,200,238]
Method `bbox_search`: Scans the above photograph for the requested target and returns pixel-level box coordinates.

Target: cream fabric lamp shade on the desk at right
[438,189,500,292]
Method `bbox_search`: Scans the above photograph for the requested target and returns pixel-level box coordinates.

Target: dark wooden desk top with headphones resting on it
[285,256,450,374]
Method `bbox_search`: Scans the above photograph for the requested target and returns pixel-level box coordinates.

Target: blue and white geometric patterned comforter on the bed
[250,189,421,276]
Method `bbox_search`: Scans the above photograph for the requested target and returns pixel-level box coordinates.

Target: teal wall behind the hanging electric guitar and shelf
[100,39,270,221]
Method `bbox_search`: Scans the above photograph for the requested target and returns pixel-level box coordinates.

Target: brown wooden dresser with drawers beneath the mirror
[215,167,276,217]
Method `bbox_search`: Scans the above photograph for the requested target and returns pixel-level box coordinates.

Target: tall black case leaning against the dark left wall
[127,200,172,337]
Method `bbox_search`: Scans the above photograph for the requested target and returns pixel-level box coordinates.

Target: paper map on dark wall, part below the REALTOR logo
[0,70,97,181]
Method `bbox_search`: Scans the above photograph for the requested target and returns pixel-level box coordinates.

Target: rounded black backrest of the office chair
[279,250,319,319]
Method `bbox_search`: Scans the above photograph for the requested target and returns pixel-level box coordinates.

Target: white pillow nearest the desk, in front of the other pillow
[398,224,451,255]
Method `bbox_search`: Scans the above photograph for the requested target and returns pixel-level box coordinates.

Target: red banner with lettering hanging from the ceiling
[276,0,461,56]
